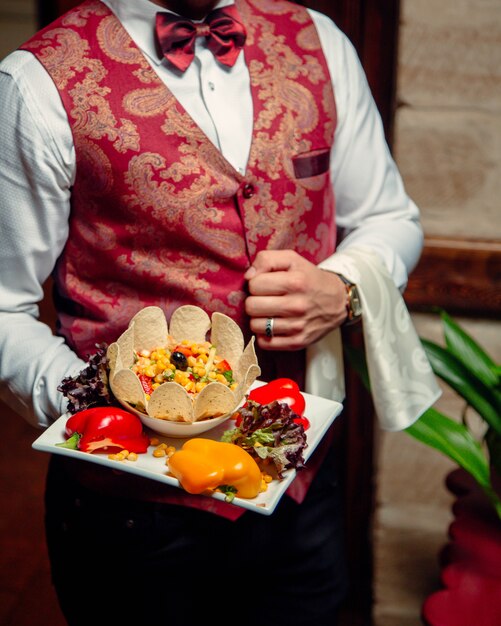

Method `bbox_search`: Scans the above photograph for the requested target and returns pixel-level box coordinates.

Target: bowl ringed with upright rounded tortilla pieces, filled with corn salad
[107,305,261,437]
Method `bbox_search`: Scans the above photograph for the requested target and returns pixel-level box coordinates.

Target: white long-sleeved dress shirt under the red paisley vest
[0,0,422,427]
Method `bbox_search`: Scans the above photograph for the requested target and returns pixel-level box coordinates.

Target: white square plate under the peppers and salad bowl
[32,393,343,515]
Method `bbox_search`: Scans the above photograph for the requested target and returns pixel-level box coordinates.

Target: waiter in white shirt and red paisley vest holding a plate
[0,0,422,626]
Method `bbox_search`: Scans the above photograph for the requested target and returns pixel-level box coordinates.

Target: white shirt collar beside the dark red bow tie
[102,0,234,65]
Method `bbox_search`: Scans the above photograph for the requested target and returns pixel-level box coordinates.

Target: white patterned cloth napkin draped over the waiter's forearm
[305,247,442,431]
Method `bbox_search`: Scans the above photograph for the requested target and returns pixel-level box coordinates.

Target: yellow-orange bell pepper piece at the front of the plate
[168,437,262,498]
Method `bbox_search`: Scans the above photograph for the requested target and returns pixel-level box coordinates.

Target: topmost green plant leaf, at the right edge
[440,311,499,388]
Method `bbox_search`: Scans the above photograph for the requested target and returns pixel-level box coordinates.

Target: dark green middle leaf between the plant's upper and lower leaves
[421,339,501,435]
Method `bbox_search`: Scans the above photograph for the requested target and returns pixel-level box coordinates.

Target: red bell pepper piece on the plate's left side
[58,406,150,454]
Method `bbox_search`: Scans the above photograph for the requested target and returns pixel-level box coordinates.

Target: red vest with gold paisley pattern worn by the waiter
[22,0,336,516]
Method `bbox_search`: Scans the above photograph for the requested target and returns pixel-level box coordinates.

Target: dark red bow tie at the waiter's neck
[156,5,247,72]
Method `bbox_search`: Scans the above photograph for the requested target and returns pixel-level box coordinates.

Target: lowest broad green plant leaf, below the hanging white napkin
[405,408,491,488]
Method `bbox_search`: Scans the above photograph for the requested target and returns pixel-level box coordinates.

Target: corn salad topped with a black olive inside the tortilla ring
[132,340,236,400]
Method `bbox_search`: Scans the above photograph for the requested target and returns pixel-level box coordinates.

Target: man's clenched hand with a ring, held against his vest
[245,250,346,350]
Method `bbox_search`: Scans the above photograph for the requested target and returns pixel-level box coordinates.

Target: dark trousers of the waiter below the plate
[46,444,347,626]
